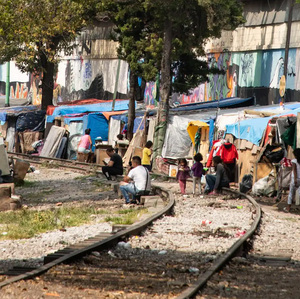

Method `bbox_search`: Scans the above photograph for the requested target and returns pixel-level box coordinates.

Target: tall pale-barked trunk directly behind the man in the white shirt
[153,20,172,168]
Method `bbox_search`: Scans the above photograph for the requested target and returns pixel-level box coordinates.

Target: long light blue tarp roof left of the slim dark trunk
[52,100,129,117]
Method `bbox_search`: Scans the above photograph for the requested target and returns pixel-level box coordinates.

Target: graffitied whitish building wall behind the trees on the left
[0,22,129,105]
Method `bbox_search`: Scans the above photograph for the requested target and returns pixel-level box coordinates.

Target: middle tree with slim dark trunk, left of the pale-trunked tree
[98,0,158,140]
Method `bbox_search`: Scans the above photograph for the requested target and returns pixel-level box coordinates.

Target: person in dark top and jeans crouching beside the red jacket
[204,156,229,195]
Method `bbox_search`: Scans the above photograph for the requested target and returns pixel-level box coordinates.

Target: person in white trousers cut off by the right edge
[283,148,300,213]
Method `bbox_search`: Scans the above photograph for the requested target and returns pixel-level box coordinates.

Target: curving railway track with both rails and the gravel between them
[0,154,261,298]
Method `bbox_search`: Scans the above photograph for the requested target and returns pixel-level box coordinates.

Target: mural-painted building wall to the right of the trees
[168,0,300,105]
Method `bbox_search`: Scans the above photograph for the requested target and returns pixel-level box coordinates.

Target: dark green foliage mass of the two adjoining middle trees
[98,0,244,92]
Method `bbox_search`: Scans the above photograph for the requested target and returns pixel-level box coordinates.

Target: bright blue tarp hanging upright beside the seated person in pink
[83,113,108,151]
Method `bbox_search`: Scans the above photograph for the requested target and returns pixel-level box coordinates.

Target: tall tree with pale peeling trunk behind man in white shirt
[145,0,244,161]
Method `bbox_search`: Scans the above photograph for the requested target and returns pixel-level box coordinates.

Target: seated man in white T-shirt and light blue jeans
[120,156,151,204]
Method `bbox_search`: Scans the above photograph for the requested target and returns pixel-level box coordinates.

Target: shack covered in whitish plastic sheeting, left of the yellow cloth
[162,113,211,159]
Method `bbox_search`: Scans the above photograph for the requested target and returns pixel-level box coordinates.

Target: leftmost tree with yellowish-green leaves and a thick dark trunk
[0,0,95,109]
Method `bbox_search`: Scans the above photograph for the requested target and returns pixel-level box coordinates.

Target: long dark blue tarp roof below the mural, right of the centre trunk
[170,97,254,112]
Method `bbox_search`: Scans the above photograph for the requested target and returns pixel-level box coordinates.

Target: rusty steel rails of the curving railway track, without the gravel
[0,154,261,299]
